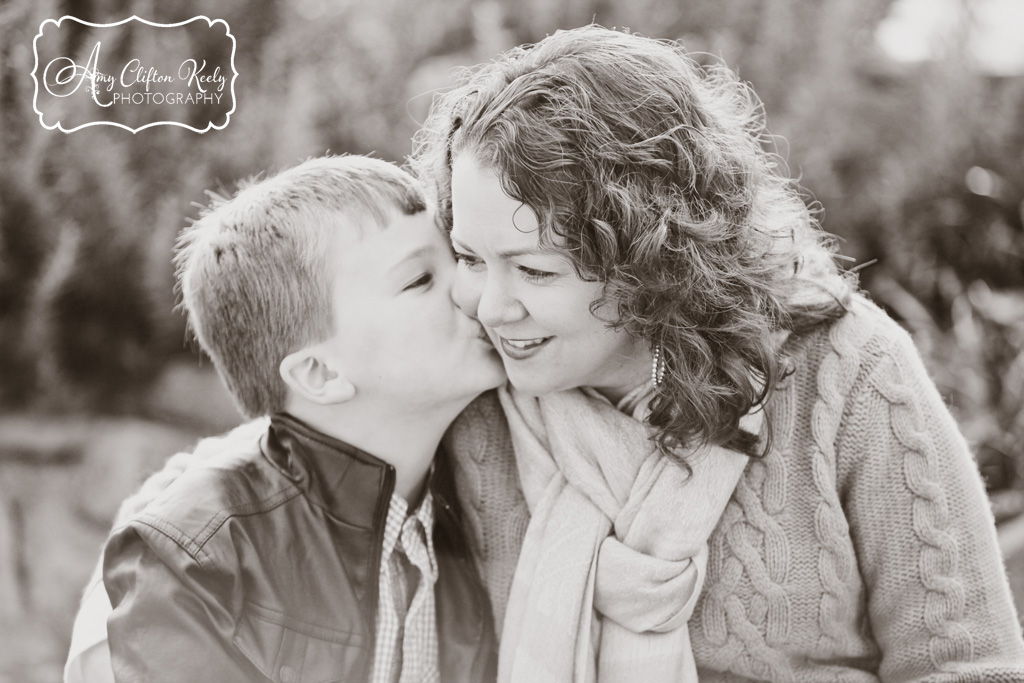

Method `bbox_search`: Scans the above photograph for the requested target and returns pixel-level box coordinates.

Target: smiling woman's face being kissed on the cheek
[452,153,651,400]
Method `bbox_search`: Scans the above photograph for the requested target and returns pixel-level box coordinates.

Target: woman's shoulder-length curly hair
[410,26,850,455]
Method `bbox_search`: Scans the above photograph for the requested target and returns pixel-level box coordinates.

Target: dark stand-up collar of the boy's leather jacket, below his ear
[264,413,395,529]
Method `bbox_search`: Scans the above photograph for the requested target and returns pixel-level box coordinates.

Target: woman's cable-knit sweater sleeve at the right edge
[837,321,1024,682]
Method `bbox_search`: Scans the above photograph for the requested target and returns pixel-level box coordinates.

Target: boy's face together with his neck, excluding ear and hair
[280,208,505,500]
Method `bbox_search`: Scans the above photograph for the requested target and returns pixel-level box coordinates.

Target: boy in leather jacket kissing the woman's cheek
[96,157,504,683]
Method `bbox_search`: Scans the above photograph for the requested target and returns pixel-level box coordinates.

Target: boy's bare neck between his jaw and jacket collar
[288,401,459,501]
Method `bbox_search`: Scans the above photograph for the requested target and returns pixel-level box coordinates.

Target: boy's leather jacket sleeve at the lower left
[103,522,266,683]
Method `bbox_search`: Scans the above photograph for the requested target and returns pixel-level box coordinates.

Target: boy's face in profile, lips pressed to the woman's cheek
[327,211,505,413]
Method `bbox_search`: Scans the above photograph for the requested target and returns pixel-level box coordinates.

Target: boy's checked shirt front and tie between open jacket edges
[371,490,439,683]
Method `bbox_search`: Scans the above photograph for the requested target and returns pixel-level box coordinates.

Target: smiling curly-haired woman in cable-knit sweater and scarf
[413,22,1024,681]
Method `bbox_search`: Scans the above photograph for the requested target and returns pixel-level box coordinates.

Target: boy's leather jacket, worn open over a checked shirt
[103,414,497,683]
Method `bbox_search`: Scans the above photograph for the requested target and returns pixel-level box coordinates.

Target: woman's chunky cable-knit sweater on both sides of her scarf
[449,297,1024,683]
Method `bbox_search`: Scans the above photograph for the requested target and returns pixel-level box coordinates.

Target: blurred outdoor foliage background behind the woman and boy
[0,0,1024,683]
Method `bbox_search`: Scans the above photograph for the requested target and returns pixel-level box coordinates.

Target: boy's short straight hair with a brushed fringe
[174,156,426,417]
